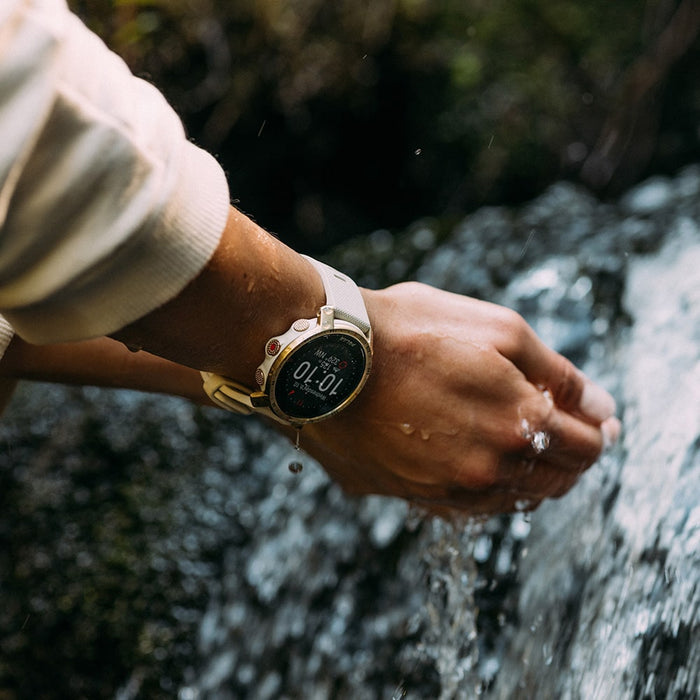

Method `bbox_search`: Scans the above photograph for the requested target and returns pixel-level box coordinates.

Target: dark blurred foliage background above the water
[70,0,700,252]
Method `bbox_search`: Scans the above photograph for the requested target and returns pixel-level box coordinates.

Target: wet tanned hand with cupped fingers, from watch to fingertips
[302,283,620,515]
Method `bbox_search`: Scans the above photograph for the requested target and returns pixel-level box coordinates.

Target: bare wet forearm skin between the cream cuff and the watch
[113,208,325,385]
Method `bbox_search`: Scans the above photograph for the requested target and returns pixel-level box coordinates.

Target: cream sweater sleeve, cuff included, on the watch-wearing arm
[0,0,229,343]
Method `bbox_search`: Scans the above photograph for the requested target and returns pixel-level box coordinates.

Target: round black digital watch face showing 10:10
[272,332,367,420]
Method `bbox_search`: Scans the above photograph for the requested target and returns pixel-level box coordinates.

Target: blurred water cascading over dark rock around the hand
[0,168,700,700]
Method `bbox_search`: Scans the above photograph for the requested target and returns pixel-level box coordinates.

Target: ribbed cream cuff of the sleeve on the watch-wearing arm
[5,143,229,344]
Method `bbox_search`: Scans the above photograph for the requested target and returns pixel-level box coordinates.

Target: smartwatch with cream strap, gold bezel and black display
[201,256,372,428]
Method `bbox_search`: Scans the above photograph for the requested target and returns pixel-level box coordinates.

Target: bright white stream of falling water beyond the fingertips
[484,226,700,698]
